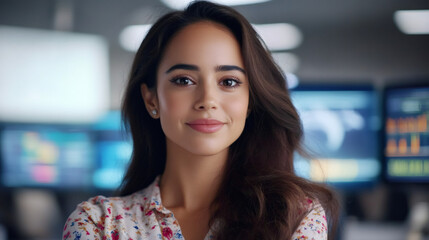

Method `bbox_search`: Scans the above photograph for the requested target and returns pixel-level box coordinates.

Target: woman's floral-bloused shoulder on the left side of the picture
[63,180,159,239]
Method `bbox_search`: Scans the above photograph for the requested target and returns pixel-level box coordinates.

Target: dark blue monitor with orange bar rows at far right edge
[384,86,429,182]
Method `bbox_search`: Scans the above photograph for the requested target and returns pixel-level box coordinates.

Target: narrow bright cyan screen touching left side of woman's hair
[93,111,133,190]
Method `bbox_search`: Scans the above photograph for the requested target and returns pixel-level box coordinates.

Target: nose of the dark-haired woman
[194,83,218,111]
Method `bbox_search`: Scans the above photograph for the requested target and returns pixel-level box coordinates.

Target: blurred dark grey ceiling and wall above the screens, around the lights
[0,0,429,106]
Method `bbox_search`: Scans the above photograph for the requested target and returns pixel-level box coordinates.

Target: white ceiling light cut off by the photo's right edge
[393,10,429,34]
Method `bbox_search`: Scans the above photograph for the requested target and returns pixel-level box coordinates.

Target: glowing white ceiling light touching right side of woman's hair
[253,23,302,51]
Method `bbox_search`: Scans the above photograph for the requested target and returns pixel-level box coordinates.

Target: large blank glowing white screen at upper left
[0,25,110,124]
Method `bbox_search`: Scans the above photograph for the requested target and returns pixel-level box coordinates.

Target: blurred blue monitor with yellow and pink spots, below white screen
[0,126,94,188]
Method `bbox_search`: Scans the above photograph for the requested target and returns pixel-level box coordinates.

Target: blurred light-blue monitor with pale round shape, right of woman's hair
[291,87,381,186]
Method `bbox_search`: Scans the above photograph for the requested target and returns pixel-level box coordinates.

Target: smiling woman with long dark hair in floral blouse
[63,2,336,240]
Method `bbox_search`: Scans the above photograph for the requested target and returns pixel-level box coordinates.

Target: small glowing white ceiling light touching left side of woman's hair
[119,24,152,52]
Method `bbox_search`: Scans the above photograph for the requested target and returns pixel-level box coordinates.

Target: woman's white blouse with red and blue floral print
[63,177,327,240]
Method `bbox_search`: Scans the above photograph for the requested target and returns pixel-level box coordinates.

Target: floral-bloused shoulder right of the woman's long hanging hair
[292,199,328,240]
